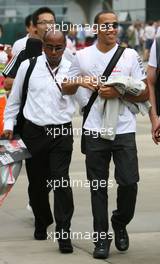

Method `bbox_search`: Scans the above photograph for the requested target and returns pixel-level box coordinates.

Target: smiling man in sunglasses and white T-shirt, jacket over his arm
[62,11,148,258]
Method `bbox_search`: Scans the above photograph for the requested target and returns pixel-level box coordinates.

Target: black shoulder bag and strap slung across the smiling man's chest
[81,46,125,154]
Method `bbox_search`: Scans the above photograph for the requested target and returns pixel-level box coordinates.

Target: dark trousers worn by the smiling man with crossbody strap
[86,133,139,236]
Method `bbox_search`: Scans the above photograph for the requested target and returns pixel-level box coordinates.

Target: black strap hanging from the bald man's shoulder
[20,57,37,111]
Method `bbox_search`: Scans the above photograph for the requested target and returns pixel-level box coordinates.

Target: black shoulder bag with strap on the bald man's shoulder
[14,57,37,136]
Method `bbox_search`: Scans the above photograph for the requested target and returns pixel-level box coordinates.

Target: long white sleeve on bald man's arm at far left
[4,61,29,131]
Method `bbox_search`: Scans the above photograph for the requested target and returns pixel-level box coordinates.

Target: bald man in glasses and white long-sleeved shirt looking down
[4,30,75,253]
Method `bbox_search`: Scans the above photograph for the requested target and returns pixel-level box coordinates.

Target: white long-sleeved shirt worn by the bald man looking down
[4,54,75,130]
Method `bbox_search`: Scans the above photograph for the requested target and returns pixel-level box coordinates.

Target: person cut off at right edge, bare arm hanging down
[147,37,160,144]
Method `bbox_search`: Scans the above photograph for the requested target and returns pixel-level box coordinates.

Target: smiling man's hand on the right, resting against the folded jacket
[98,86,120,99]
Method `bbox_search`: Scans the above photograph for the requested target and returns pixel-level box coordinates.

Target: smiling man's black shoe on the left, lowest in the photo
[93,240,112,259]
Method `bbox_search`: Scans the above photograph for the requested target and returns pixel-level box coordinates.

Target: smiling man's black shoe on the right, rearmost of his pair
[113,227,129,251]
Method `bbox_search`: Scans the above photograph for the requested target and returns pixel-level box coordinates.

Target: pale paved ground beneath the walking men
[0,116,160,264]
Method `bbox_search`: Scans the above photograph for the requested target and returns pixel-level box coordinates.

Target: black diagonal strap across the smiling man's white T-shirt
[82,46,125,125]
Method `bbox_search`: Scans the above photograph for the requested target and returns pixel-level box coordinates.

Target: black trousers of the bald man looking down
[22,121,74,231]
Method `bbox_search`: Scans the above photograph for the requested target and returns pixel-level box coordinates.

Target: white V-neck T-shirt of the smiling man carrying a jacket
[68,44,146,134]
